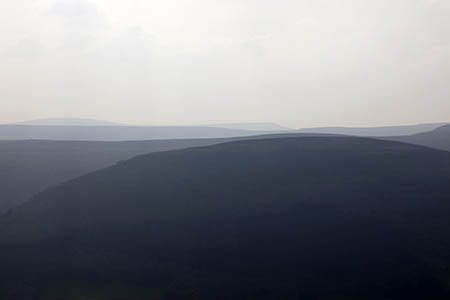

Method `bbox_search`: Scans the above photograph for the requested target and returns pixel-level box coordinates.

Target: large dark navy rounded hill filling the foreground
[0,137,450,299]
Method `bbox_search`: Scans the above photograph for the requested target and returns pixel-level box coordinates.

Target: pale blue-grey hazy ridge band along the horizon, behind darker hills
[0,123,442,141]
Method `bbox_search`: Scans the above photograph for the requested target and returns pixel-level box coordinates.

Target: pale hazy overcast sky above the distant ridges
[0,0,450,127]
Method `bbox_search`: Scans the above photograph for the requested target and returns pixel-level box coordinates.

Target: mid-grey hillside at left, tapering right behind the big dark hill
[0,134,330,213]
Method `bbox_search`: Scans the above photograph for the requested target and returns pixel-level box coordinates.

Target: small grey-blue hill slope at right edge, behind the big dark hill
[384,125,450,151]
